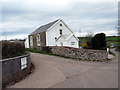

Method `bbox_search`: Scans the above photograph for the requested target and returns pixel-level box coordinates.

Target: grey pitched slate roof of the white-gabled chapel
[30,19,59,35]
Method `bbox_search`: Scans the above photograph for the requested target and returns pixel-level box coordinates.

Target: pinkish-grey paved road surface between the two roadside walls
[8,50,118,88]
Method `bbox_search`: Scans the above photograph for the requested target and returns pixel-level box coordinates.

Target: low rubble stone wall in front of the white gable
[50,46,108,61]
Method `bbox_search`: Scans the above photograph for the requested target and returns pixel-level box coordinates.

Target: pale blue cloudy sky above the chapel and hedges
[0,0,118,40]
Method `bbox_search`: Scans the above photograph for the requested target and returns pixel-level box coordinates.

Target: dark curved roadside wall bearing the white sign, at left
[0,54,31,88]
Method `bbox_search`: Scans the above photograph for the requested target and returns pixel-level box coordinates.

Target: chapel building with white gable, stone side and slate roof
[29,19,79,48]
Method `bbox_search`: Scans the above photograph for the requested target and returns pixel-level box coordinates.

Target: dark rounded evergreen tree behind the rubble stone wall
[91,33,106,50]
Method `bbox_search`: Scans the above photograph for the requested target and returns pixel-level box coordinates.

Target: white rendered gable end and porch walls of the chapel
[46,21,78,48]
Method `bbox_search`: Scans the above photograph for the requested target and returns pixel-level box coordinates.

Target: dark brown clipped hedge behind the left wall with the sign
[1,41,25,59]
